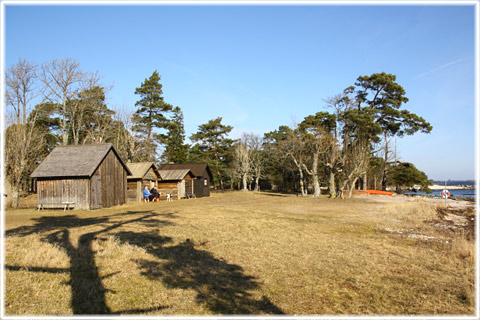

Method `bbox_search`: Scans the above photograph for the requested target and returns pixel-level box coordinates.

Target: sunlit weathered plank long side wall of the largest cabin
[37,178,89,209]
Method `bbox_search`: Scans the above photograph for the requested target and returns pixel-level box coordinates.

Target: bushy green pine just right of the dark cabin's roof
[190,117,234,190]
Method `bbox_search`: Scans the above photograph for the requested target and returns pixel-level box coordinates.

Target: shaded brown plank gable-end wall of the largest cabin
[91,150,127,209]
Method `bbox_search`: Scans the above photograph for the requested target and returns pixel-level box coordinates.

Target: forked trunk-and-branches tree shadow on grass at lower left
[5,211,173,314]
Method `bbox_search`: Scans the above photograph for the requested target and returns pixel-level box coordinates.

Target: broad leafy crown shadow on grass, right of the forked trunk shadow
[114,232,283,314]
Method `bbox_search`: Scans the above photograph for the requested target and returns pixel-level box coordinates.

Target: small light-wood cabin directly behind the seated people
[127,162,160,202]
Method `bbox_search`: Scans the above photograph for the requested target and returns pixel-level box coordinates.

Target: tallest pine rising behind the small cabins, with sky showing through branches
[132,70,172,161]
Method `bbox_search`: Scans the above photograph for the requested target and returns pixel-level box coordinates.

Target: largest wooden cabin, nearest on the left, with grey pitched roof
[30,144,131,209]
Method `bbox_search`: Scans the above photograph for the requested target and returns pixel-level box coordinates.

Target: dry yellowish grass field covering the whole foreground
[5,192,475,315]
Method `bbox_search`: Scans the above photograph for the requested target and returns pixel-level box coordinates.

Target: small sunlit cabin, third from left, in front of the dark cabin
[157,169,195,200]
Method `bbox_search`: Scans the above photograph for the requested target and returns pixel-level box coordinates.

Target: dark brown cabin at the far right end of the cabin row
[158,163,213,198]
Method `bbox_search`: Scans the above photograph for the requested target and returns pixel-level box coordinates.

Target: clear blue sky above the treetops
[2,1,478,180]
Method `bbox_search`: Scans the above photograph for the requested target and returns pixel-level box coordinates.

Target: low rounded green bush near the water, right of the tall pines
[388,162,432,193]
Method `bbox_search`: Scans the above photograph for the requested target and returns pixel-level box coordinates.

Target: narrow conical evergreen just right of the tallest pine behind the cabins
[161,106,189,163]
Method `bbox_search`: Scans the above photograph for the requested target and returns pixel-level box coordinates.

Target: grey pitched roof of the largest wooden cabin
[30,143,131,178]
